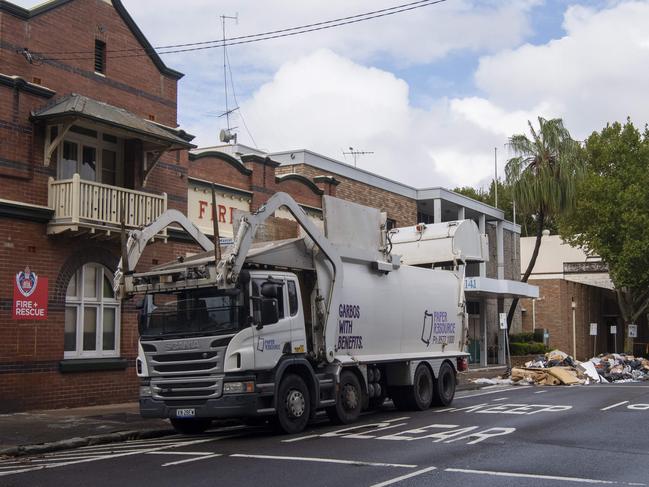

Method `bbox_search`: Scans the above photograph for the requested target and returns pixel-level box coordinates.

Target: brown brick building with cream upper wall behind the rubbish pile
[521,232,649,360]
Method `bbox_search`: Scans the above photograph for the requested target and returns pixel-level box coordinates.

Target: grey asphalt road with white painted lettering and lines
[0,382,649,487]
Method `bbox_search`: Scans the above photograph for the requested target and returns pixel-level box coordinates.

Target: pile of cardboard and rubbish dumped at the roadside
[475,350,649,385]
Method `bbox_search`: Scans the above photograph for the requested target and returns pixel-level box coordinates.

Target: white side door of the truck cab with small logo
[250,275,292,370]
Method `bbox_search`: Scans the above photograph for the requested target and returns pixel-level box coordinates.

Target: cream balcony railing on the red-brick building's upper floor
[48,174,167,236]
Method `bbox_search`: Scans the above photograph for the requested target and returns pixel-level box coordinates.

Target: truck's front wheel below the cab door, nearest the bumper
[277,374,311,435]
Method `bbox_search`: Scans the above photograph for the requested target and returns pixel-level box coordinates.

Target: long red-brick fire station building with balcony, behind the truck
[0,0,533,413]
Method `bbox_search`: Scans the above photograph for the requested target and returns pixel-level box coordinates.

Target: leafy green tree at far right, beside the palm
[560,120,649,340]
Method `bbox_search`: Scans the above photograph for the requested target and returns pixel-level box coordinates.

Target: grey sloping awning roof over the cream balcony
[31,93,195,150]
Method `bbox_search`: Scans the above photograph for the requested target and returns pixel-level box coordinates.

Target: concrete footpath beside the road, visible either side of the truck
[0,367,505,456]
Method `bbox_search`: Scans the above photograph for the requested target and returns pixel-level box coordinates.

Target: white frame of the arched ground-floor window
[63,262,121,359]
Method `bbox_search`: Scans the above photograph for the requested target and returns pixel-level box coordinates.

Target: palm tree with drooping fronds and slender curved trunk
[505,117,583,329]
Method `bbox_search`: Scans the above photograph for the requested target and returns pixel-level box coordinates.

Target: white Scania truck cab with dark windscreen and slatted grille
[137,270,308,432]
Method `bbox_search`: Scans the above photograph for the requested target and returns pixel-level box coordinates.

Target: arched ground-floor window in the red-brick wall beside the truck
[64,263,120,358]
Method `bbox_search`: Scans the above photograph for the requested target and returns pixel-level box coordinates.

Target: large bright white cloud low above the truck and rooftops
[242,50,502,187]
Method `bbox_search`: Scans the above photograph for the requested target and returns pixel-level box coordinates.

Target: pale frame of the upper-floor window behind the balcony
[54,123,124,187]
